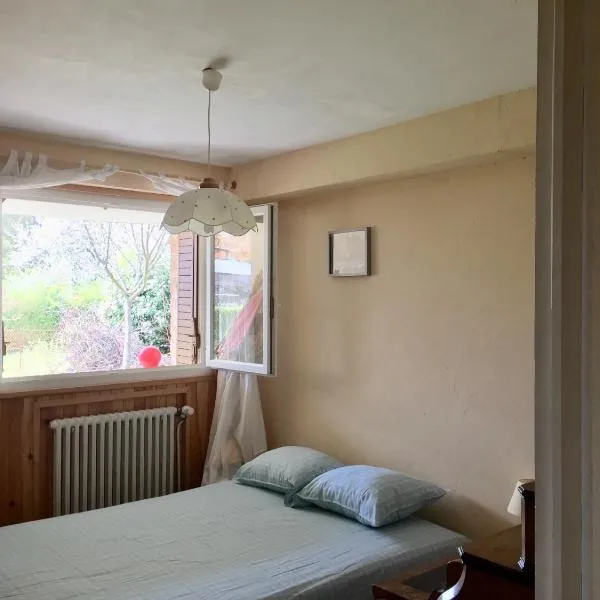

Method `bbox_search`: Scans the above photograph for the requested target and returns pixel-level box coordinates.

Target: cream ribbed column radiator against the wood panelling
[50,406,194,516]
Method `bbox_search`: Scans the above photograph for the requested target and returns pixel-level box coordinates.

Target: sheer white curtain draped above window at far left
[0,150,119,192]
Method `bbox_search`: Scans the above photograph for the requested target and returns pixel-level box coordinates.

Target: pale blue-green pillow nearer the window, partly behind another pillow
[234,446,343,504]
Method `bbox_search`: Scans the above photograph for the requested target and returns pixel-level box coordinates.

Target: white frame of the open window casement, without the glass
[204,204,277,375]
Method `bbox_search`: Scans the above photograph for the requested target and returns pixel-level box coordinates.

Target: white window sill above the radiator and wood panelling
[0,365,214,398]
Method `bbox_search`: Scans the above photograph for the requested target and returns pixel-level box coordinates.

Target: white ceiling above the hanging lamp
[0,0,537,164]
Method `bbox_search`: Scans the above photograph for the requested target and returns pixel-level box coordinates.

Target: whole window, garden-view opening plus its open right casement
[0,190,275,378]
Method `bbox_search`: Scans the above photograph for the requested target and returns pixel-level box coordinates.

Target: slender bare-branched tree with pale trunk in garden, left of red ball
[82,222,166,369]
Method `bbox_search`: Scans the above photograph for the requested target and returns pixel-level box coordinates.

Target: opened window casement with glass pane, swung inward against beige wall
[206,205,275,375]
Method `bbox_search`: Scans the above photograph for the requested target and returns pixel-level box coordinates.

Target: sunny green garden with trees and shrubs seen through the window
[2,214,171,377]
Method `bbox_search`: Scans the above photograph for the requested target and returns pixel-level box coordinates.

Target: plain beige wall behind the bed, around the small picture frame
[261,157,534,536]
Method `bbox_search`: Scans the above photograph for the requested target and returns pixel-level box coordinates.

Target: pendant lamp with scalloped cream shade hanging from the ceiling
[162,67,256,237]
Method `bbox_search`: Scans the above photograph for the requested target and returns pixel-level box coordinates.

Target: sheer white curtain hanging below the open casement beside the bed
[202,371,267,485]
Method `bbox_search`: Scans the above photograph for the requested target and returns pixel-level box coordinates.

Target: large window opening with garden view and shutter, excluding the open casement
[2,191,197,377]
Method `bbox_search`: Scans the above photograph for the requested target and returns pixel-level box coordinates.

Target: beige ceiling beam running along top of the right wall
[231,88,536,203]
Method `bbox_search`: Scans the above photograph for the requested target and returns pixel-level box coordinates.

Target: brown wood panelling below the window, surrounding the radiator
[0,375,216,526]
